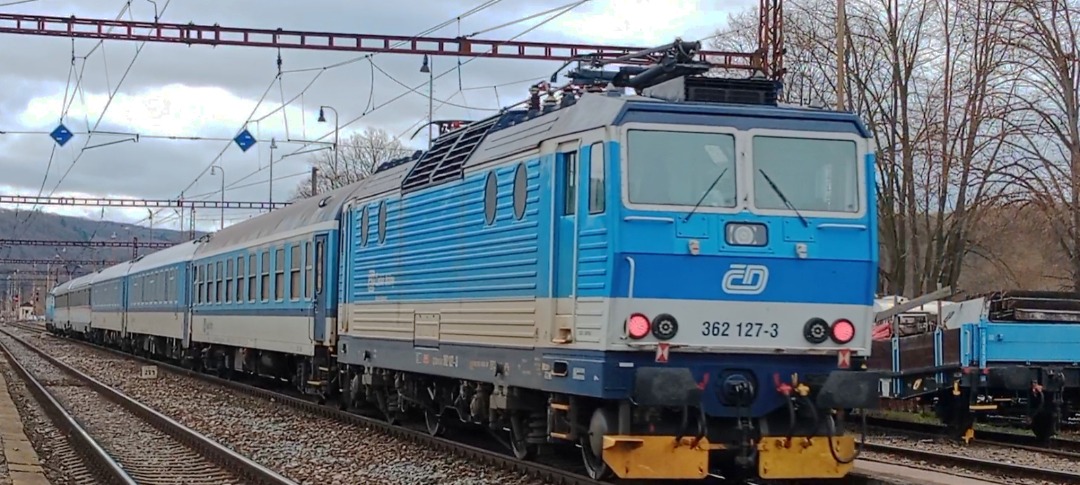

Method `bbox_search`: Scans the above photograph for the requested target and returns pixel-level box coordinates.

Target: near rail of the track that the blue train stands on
[4,323,608,485]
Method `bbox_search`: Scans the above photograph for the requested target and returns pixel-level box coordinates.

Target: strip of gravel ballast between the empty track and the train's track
[8,331,543,485]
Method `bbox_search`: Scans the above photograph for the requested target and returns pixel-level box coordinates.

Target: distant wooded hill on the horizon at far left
[0,208,201,278]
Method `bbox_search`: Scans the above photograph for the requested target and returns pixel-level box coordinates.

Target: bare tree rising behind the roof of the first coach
[295,127,413,199]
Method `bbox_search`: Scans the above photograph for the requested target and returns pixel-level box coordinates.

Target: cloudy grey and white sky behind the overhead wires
[0,0,757,230]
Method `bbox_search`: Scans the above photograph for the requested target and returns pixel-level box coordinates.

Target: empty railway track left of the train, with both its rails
[0,329,296,485]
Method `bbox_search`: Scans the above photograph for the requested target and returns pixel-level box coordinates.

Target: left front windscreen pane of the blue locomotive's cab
[626,130,737,208]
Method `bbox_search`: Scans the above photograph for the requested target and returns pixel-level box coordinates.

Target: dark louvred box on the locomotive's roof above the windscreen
[644,76,780,106]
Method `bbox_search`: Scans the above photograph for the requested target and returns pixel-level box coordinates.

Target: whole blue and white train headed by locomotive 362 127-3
[46,42,878,479]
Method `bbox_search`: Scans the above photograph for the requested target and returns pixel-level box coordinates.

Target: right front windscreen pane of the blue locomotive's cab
[753,136,859,213]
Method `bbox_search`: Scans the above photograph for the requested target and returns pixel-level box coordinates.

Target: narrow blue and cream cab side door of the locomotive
[551,140,581,343]
